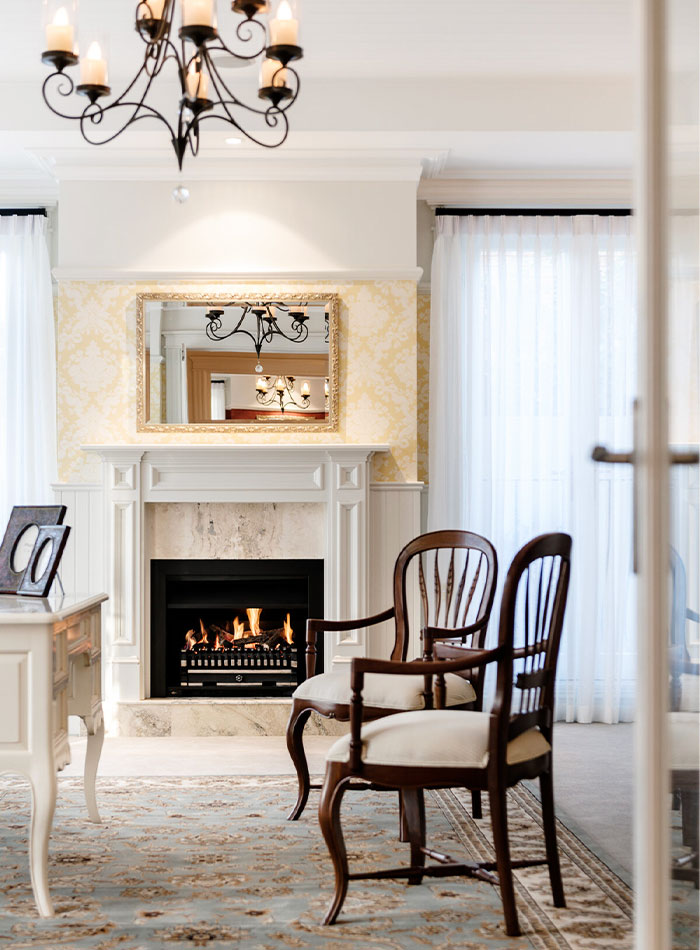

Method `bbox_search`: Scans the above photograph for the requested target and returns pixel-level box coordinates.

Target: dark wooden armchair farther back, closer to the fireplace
[287,531,498,821]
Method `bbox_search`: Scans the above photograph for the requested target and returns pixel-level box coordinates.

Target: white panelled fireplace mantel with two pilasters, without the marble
[82,443,389,704]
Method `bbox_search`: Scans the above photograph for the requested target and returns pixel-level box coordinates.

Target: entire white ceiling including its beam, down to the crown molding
[0,0,680,198]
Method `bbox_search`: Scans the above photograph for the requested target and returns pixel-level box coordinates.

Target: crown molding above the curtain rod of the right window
[418,175,633,208]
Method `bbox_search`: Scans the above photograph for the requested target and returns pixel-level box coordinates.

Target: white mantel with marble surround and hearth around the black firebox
[78,444,396,736]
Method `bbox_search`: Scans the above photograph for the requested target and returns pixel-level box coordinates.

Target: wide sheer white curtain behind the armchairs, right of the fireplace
[428,215,636,722]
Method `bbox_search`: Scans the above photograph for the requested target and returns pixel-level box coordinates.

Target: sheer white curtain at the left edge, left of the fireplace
[0,215,56,534]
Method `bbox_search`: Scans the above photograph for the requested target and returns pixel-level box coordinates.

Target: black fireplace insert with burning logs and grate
[151,559,323,698]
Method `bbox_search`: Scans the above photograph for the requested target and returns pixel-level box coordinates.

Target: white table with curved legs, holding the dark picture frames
[0,594,107,917]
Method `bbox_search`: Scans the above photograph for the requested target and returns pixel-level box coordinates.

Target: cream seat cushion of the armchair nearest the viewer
[326,709,551,769]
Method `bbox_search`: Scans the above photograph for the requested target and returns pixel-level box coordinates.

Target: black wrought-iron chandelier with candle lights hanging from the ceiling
[41,0,302,169]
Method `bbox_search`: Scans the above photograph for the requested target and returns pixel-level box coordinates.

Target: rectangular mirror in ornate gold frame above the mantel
[136,293,340,432]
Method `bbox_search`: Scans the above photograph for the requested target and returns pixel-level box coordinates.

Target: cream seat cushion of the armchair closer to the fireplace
[293,669,476,709]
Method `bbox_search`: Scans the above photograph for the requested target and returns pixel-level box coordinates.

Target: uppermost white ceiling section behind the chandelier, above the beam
[6,0,633,81]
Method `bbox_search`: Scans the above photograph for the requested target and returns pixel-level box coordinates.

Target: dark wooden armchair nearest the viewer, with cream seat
[319,534,571,936]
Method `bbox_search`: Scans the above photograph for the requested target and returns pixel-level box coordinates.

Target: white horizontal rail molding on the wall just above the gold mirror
[53,267,423,284]
